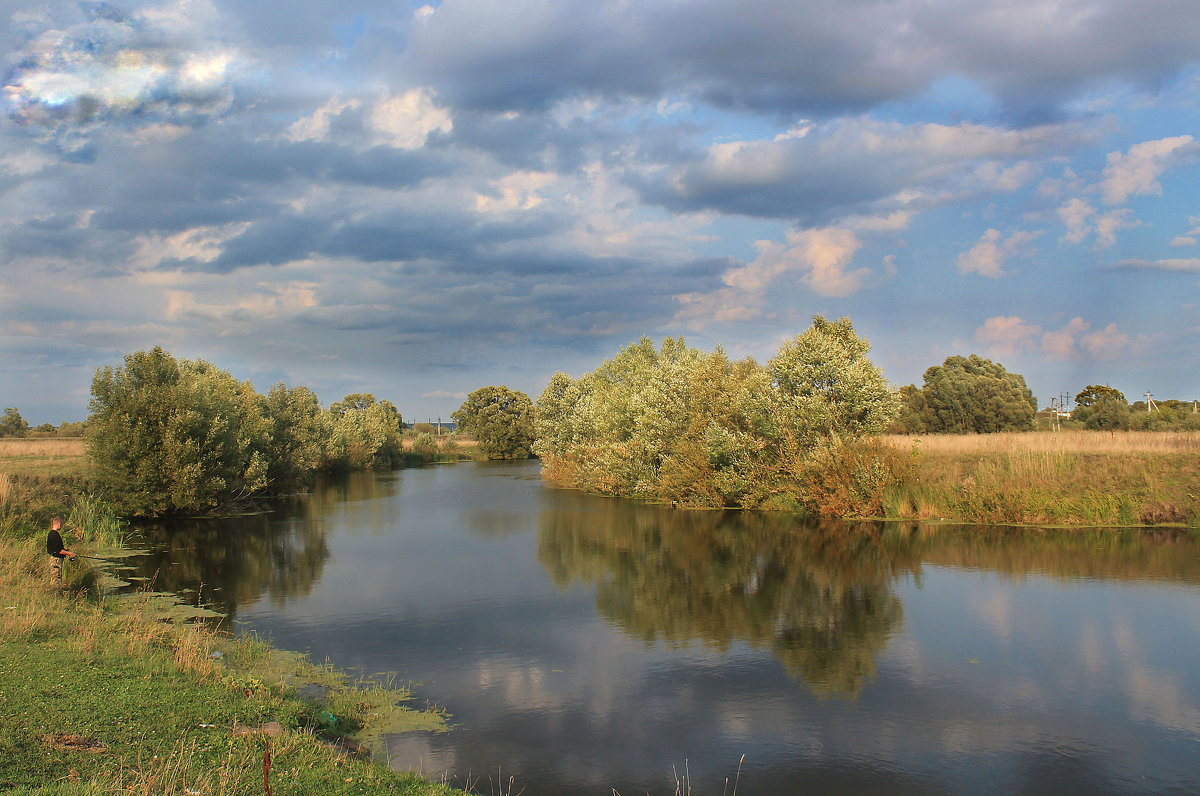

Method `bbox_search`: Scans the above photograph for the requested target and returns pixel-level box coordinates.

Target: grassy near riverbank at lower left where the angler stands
[0,479,462,796]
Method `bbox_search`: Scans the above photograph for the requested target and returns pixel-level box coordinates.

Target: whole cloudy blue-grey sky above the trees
[0,0,1200,425]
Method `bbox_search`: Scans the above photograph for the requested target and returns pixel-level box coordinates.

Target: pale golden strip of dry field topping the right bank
[883,431,1200,456]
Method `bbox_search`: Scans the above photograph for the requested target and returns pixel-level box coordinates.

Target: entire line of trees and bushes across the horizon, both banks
[37,316,1200,515]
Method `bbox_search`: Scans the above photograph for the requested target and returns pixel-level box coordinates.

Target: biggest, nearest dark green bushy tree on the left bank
[86,347,270,515]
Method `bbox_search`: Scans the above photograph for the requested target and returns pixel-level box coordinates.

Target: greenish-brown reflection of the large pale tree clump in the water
[538,502,919,696]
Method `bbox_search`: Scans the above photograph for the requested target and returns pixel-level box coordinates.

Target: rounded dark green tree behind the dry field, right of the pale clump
[922,354,1038,433]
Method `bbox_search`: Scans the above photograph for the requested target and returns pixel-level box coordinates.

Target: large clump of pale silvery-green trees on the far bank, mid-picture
[534,316,899,507]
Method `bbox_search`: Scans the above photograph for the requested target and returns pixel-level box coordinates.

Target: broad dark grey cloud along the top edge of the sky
[403,0,1200,116]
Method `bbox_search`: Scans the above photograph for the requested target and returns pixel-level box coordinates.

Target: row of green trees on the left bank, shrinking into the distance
[85,347,463,515]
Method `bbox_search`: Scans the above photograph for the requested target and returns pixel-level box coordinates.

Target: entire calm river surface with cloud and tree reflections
[126,462,1200,796]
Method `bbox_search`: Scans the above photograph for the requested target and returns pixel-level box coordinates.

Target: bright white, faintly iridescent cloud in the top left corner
[5,0,259,152]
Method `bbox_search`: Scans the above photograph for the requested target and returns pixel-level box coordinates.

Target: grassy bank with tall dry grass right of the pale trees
[882,431,1200,526]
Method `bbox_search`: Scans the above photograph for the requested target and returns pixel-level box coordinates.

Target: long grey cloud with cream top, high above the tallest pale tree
[631,116,1078,226]
